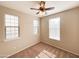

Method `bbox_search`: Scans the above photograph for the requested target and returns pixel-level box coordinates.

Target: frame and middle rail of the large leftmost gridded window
[4,14,20,41]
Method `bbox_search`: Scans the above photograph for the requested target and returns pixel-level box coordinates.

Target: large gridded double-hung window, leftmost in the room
[5,14,19,40]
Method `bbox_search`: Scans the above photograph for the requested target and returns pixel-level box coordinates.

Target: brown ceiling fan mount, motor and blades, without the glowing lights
[30,1,55,14]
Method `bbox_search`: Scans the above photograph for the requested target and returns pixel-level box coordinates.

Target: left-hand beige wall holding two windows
[0,6,40,57]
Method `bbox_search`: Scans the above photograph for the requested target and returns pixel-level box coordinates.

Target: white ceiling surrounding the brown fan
[0,1,79,17]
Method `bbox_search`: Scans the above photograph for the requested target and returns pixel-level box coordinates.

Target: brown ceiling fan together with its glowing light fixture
[31,1,54,17]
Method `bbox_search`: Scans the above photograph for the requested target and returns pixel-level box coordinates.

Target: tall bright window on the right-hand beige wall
[49,17,60,40]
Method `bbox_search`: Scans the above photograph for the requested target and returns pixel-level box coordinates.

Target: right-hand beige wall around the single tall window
[41,7,79,55]
